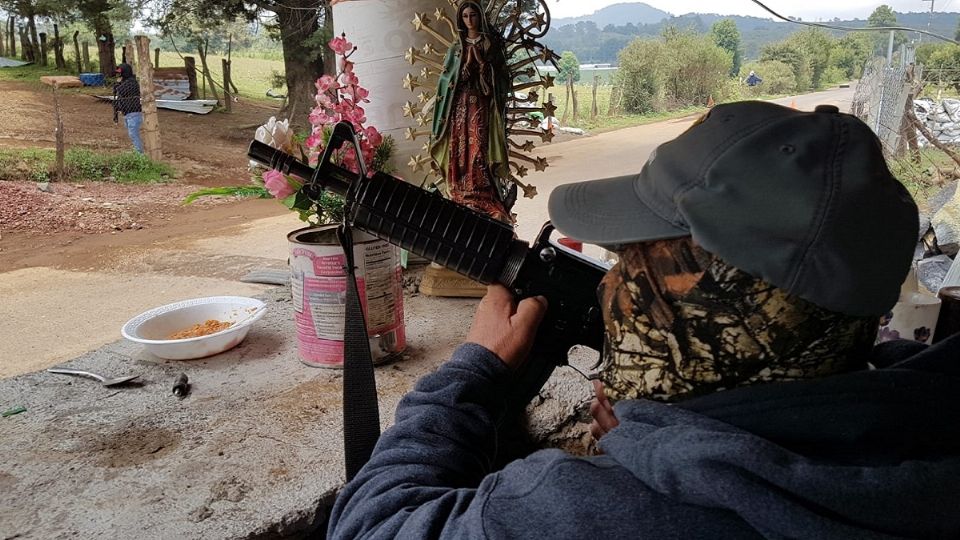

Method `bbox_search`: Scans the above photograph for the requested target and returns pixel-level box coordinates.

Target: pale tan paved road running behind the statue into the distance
[0,89,853,378]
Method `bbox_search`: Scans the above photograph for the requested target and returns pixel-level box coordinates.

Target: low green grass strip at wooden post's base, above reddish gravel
[0,148,174,184]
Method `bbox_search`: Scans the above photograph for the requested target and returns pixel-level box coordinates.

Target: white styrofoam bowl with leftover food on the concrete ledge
[120,296,267,360]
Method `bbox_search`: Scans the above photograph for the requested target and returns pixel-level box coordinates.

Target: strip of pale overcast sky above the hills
[549,0,960,21]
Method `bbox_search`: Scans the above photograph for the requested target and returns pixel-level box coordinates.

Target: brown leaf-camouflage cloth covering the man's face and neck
[598,237,878,401]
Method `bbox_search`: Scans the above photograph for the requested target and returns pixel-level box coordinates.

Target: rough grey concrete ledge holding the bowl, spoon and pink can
[0,288,477,538]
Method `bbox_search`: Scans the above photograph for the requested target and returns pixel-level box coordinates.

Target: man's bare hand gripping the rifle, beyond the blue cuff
[467,285,547,370]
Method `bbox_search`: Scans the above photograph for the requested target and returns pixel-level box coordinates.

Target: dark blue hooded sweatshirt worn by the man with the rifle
[328,336,960,539]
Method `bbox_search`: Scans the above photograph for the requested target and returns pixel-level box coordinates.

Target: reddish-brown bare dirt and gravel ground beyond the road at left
[0,81,285,272]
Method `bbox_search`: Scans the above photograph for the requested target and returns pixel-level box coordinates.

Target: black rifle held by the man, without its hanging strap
[248,122,607,469]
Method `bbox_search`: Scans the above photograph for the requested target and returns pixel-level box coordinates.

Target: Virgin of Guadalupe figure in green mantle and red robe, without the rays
[430,1,517,223]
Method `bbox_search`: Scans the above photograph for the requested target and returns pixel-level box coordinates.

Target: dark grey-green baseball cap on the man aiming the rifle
[549,101,919,316]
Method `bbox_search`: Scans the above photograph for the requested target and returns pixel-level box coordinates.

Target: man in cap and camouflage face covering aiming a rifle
[328,102,960,539]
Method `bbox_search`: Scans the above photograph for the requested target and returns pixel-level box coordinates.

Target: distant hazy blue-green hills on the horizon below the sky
[543,3,960,64]
